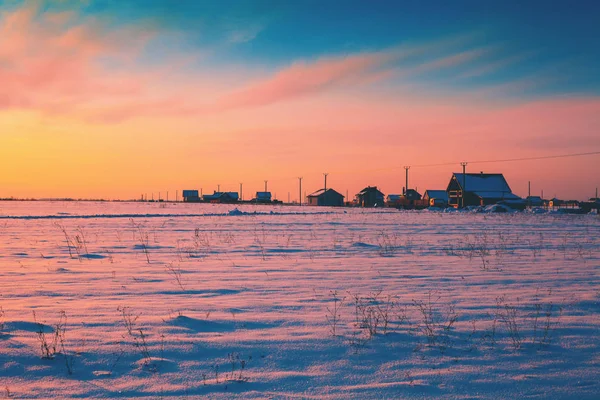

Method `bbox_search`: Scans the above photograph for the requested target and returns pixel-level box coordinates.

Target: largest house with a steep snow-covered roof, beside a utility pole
[446,172,522,207]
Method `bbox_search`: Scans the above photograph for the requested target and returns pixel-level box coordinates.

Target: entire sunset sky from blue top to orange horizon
[0,0,600,200]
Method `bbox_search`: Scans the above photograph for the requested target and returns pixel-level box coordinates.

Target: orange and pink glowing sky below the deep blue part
[0,2,600,200]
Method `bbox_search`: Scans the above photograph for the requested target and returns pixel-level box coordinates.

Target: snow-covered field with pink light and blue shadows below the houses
[0,202,600,399]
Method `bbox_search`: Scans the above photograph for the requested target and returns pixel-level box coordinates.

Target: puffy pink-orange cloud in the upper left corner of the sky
[0,6,157,113]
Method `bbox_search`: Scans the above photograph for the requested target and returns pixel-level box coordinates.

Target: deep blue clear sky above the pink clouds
[58,0,600,95]
